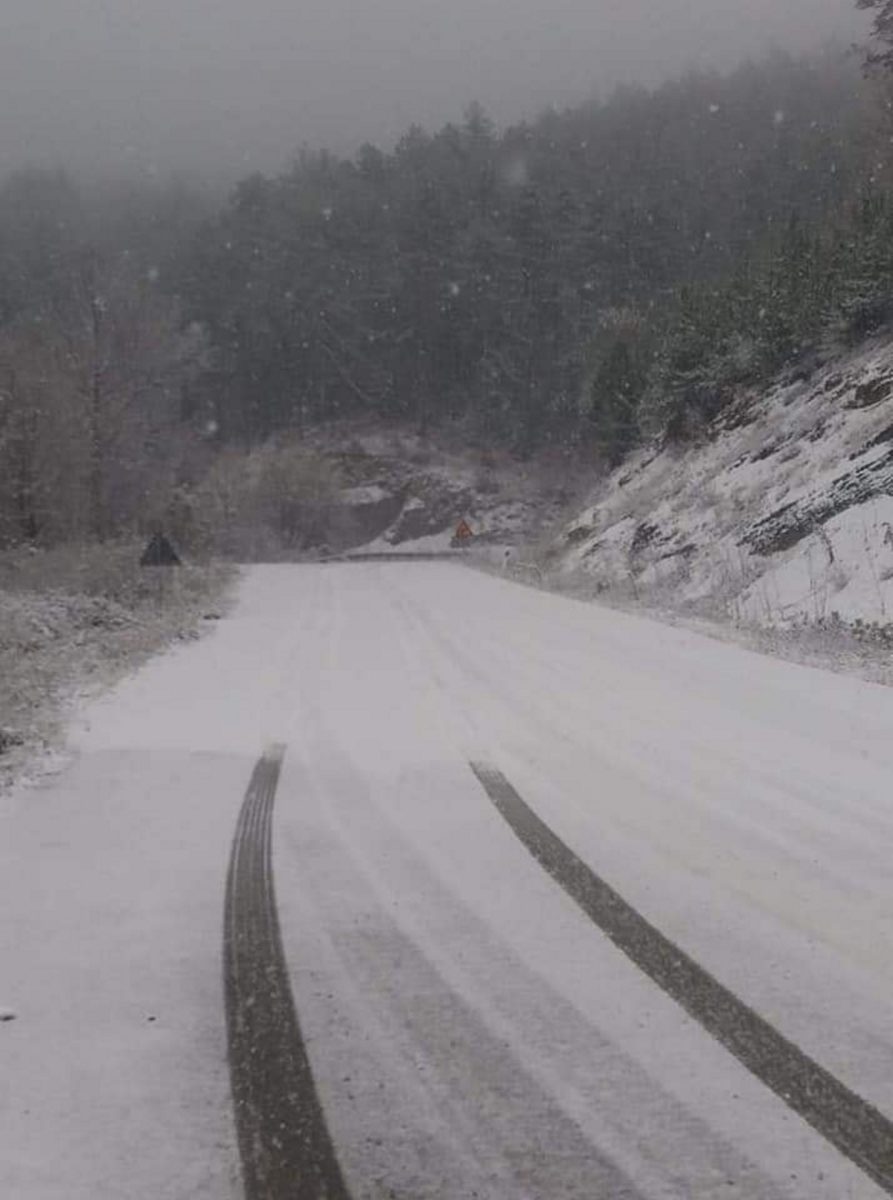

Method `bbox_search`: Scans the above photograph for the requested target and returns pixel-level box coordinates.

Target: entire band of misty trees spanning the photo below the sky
[0,45,893,542]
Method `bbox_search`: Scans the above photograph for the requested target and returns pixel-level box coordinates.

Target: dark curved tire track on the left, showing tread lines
[223,745,349,1200]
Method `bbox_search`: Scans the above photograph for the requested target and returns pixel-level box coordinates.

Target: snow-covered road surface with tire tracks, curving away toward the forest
[0,562,893,1200]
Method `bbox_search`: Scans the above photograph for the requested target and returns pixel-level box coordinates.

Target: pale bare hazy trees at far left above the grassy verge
[0,172,210,545]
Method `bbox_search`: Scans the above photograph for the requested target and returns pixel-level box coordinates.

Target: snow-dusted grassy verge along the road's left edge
[0,545,232,788]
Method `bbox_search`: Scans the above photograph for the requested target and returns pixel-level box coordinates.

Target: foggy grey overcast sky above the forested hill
[0,0,864,182]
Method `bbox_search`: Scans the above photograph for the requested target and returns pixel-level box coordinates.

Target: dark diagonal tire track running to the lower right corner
[471,763,893,1195]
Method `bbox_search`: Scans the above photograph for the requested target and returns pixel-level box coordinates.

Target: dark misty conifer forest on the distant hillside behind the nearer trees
[182,56,879,451]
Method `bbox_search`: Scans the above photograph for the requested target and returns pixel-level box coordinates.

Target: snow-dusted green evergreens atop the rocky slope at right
[643,187,893,441]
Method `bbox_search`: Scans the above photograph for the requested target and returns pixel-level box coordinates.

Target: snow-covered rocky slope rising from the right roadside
[556,333,893,625]
